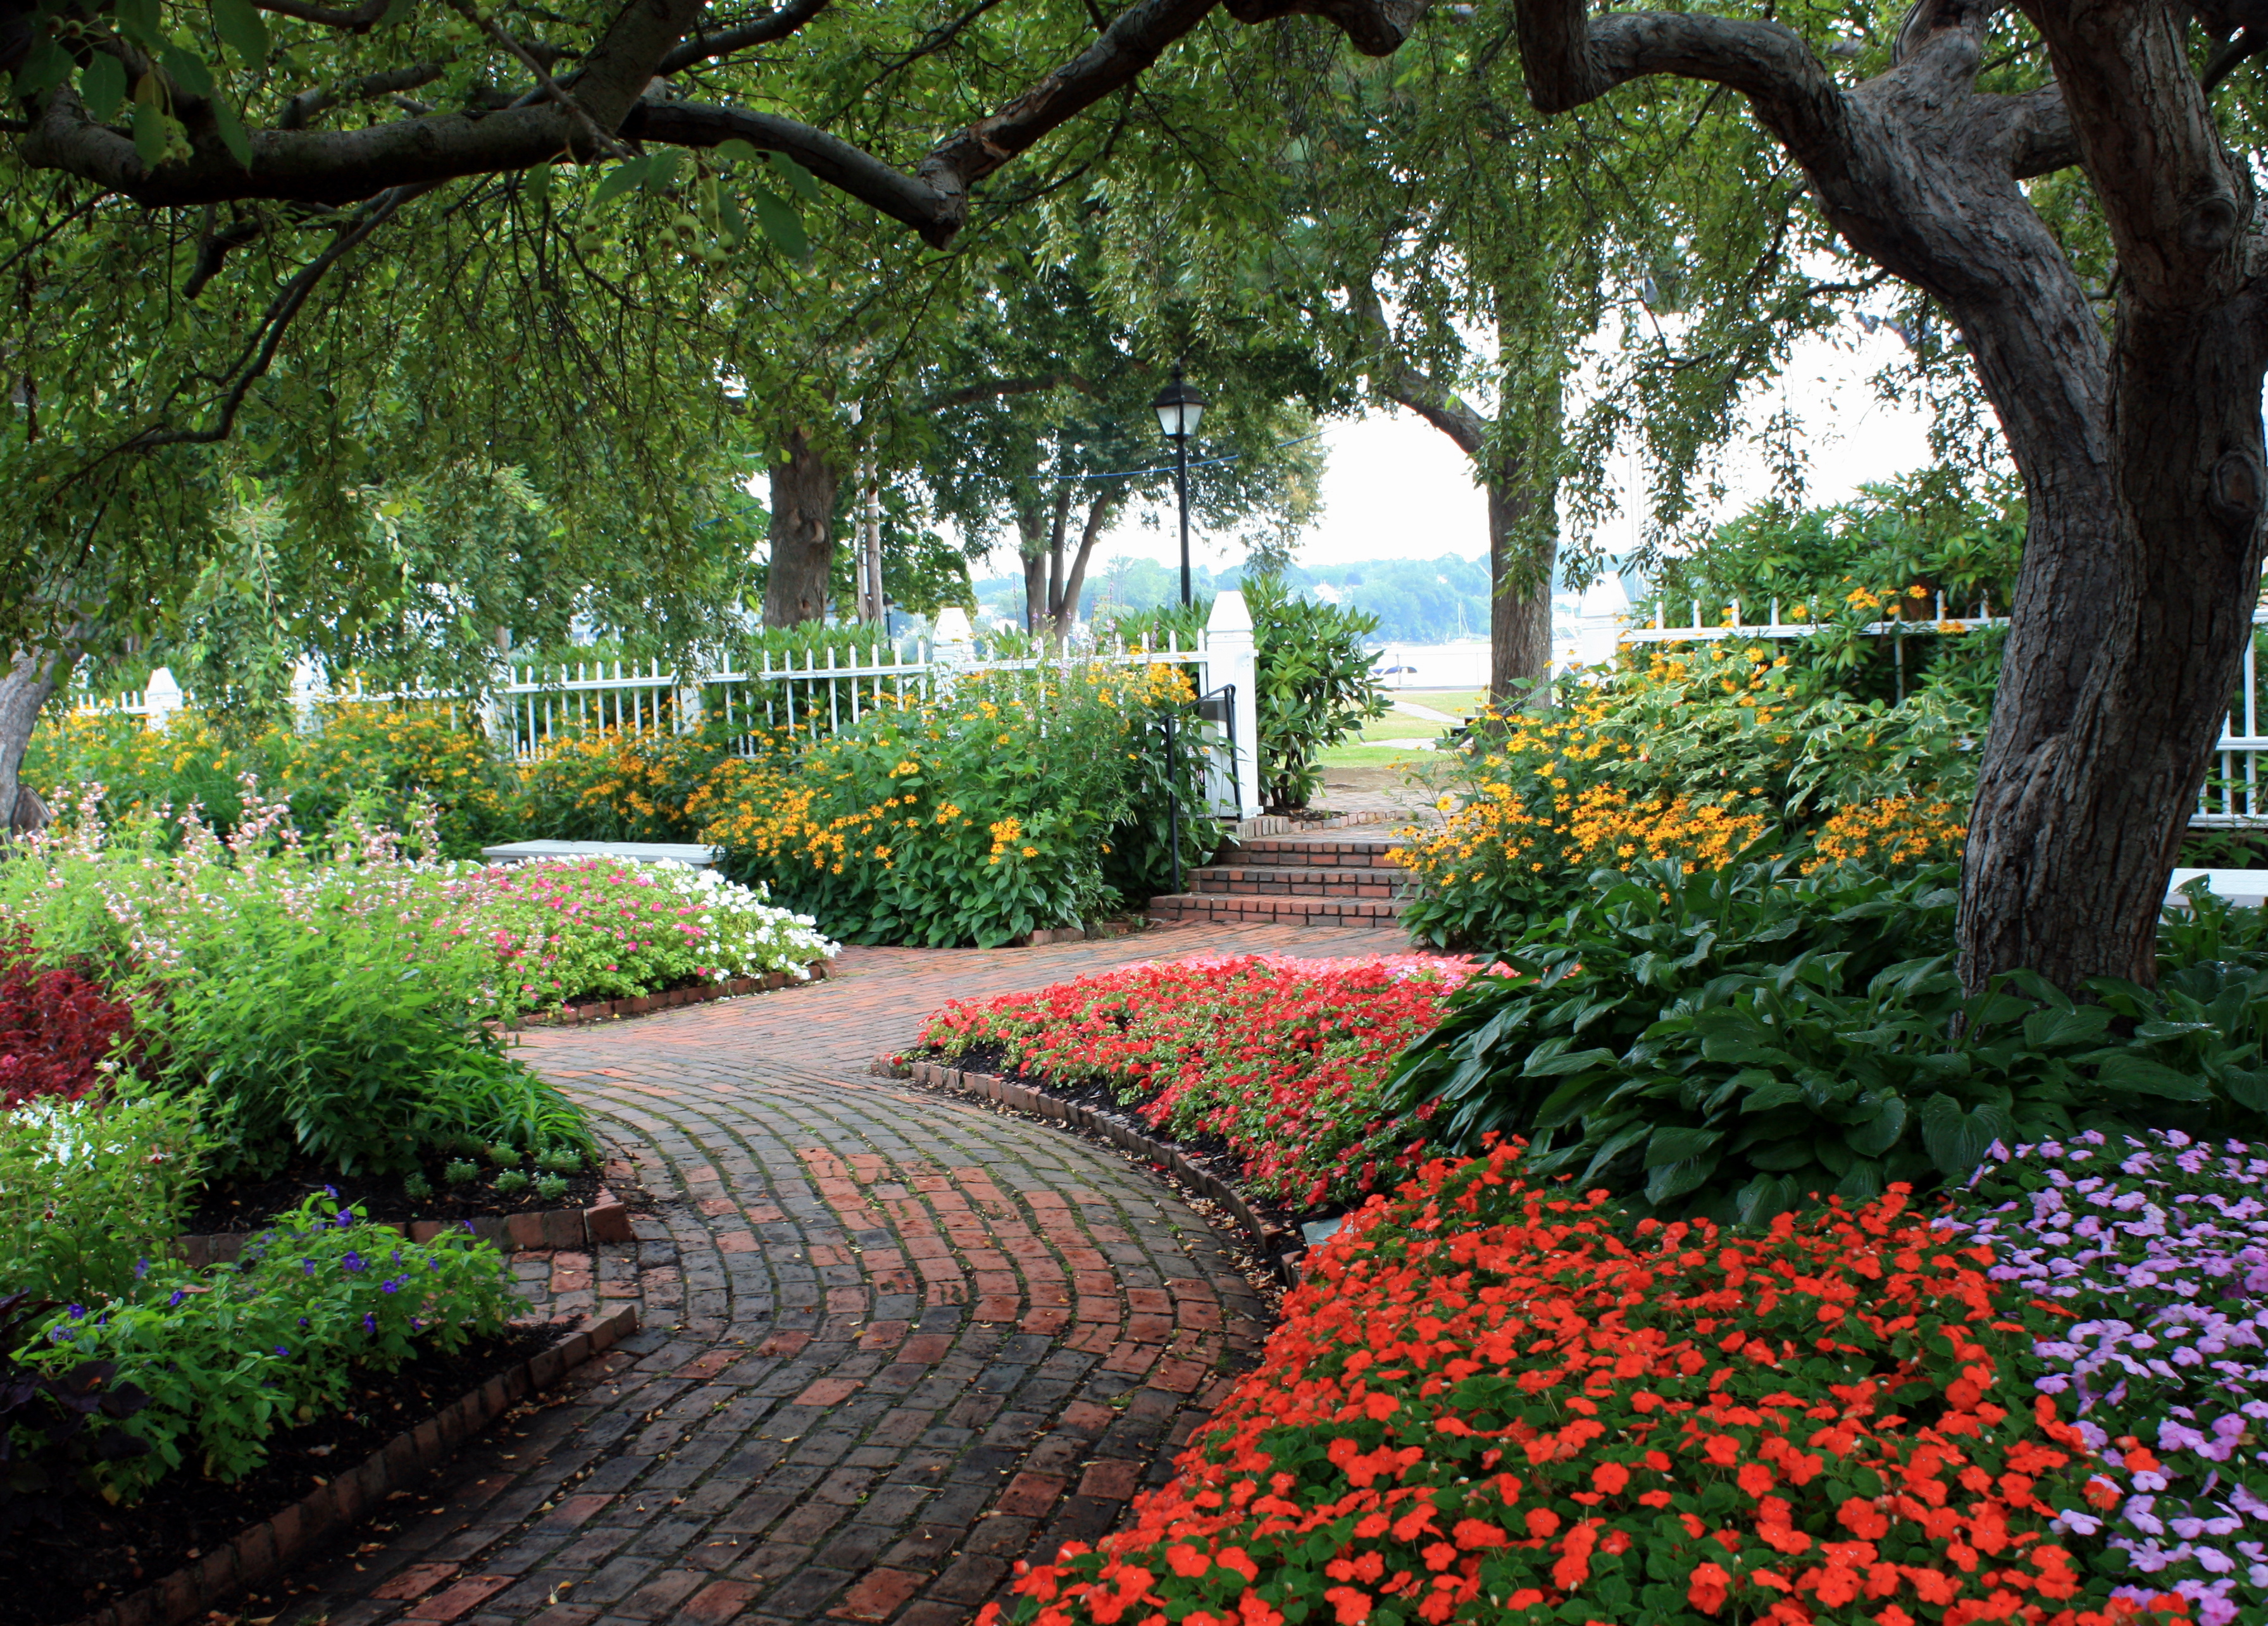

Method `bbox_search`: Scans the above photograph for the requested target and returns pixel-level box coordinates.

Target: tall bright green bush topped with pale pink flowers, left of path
[0,800,587,1175]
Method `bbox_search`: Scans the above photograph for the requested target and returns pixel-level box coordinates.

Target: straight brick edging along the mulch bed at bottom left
[73,1306,637,1626]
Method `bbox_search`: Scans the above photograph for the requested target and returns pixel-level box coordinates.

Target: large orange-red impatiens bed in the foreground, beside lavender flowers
[980,1148,2186,1626]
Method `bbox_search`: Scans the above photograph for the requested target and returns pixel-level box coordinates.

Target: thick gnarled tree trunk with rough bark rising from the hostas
[1517,0,2268,989]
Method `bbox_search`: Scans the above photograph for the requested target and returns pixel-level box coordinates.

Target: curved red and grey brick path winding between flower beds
[270,925,1402,1626]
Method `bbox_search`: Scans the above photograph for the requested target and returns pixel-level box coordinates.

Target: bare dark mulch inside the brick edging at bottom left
[0,1327,560,1626]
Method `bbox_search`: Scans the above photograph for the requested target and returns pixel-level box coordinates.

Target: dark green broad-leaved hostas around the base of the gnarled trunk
[1397,862,2268,1222]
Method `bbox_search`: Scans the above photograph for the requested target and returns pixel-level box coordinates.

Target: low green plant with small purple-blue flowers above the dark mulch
[27,1198,520,1501]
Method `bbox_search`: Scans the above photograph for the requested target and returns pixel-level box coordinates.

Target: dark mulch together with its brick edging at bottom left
[0,1313,635,1626]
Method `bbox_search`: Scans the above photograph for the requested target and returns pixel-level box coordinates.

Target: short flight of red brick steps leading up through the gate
[1150,826,1409,928]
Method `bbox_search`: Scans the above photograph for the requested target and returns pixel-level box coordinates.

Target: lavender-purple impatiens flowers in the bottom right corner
[1960,1132,2268,1626]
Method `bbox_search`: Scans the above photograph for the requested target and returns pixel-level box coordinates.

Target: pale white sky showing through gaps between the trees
[1095,320,1930,567]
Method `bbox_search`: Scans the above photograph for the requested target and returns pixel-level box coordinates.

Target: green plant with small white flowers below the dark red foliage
[0,1098,199,1304]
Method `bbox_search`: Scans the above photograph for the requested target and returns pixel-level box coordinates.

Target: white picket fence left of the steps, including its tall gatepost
[82,592,1259,819]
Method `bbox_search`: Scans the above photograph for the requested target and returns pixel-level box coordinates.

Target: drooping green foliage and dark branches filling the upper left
[0,0,1422,814]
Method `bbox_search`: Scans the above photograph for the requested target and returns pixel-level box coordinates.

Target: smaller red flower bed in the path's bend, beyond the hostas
[921,955,1474,1207]
